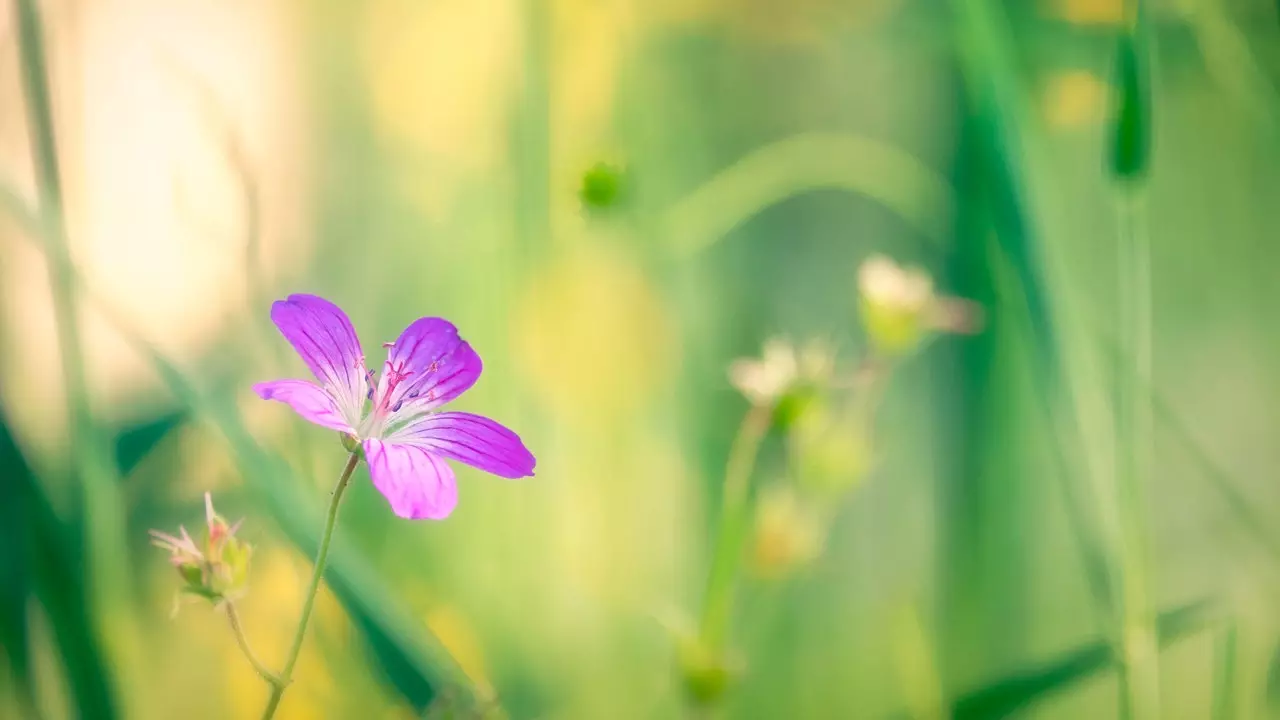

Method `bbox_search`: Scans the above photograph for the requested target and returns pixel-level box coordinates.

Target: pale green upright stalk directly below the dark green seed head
[1115,188,1160,720]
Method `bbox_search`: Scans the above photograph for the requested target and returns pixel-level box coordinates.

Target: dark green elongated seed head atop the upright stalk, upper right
[1111,31,1151,181]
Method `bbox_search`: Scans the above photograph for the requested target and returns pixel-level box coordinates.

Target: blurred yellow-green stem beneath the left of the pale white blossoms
[699,405,773,651]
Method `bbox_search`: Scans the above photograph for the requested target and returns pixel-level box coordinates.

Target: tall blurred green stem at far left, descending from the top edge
[14,0,127,605]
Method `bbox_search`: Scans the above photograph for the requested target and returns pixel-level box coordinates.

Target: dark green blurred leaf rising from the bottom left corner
[0,407,115,720]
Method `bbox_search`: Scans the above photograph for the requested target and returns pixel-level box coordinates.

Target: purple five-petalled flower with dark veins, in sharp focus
[253,295,535,520]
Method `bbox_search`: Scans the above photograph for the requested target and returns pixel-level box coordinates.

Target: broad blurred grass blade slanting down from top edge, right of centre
[946,0,1125,696]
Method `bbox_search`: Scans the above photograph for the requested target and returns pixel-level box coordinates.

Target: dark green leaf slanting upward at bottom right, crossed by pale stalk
[951,602,1211,720]
